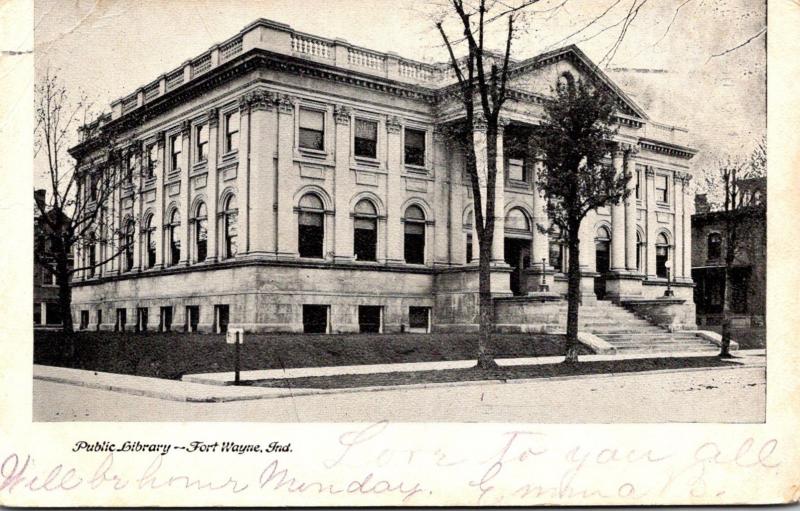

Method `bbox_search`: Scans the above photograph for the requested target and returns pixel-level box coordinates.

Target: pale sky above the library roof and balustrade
[34,0,766,184]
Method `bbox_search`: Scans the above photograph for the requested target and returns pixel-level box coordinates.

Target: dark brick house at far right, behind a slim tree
[692,178,767,326]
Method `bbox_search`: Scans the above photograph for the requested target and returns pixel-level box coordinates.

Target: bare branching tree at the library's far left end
[34,70,141,340]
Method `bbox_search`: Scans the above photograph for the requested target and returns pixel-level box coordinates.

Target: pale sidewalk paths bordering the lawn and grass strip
[33,350,766,403]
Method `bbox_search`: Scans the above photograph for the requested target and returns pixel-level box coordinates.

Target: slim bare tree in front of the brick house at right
[703,139,767,357]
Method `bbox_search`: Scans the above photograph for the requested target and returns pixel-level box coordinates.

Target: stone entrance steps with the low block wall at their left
[498,300,719,355]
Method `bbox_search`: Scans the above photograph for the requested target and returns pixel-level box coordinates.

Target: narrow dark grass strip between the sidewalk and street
[248,356,740,389]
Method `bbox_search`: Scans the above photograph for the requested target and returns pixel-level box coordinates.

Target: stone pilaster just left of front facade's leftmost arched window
[276,96,298,259]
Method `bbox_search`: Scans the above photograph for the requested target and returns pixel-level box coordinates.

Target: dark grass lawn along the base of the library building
[33,331,589,380]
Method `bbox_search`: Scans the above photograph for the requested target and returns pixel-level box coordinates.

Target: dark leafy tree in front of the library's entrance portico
[531,80,630,363]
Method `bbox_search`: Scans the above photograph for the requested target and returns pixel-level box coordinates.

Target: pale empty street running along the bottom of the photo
[33,367,766,423]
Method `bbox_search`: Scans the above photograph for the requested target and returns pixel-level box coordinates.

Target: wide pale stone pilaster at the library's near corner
[248,90,278,256]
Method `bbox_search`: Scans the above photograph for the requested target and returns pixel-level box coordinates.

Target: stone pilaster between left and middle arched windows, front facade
[334,105,353,262]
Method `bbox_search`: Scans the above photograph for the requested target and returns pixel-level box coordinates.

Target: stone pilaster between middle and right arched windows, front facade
[386,117,404,264]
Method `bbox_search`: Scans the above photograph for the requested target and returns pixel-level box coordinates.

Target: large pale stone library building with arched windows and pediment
[70,19,695,332]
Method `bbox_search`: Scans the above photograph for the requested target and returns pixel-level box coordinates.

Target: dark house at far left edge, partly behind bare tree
[33,190,72,328]
